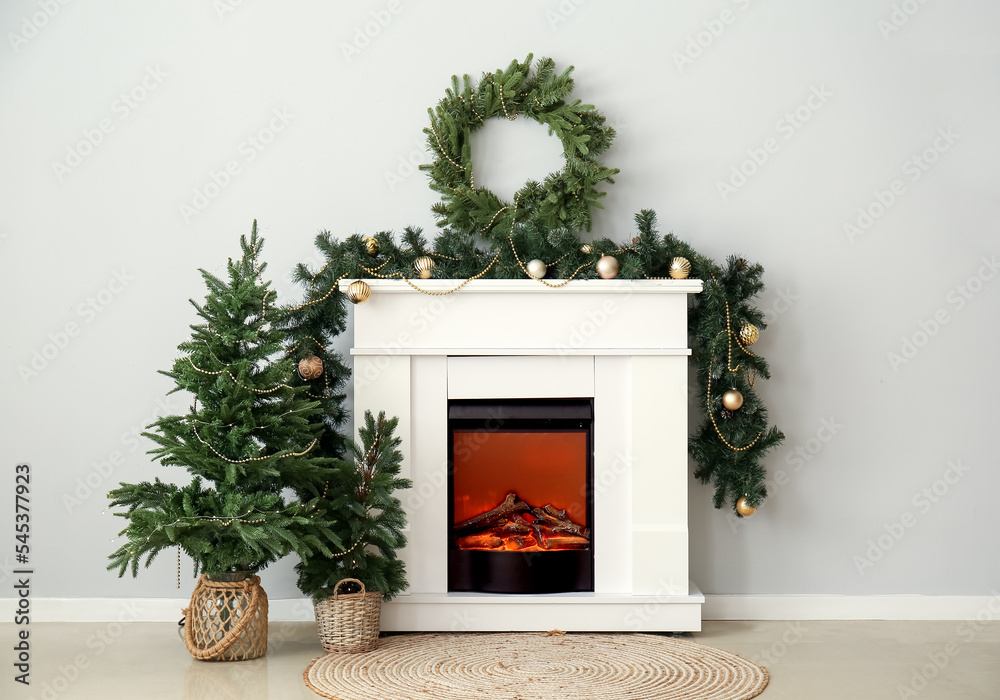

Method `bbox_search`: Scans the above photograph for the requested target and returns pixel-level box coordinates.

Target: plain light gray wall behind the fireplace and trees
[0,0,1000,598]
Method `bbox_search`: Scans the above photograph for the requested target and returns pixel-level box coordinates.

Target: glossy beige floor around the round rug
[0,621,1000,700]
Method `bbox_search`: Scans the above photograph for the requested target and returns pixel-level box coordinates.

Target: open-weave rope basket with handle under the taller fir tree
[184,575,267,661]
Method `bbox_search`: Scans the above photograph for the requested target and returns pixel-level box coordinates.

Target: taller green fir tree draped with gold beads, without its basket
[108,221,341,576]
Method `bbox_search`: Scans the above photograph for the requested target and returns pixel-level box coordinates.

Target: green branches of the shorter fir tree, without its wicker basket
[295,411,411,600]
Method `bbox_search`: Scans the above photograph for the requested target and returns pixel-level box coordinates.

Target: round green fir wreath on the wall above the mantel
[420,54,618,239]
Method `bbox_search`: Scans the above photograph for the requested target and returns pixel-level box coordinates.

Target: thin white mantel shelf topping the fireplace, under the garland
[340,278,702,294]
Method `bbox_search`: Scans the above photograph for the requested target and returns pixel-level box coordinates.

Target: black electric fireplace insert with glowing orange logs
[448,399,594,594]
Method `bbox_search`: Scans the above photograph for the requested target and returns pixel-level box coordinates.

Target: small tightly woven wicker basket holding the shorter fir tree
[315,578,382,653]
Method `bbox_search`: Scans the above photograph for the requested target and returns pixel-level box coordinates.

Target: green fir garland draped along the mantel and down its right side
[298,210,784,517]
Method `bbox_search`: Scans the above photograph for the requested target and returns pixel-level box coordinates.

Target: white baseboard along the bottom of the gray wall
[7,591,1000,622]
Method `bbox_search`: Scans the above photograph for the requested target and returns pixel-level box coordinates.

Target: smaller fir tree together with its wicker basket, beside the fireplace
[296,411,411,652]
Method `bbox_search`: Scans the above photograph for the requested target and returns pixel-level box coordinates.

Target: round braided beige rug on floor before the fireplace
[303,633,768,700]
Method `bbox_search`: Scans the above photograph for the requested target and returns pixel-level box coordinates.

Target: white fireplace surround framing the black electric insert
[341,280,704,631]
